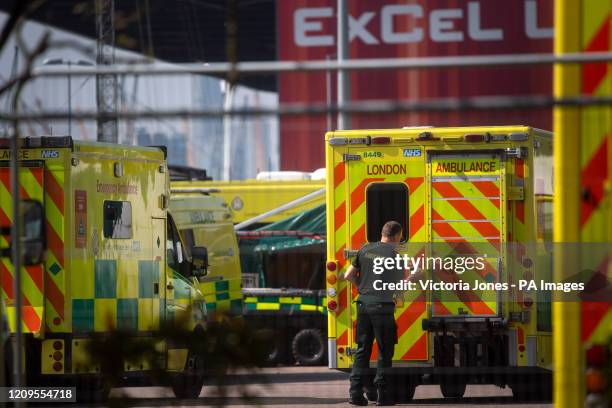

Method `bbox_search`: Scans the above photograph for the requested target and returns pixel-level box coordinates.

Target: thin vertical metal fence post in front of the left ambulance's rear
[10,129,23,387]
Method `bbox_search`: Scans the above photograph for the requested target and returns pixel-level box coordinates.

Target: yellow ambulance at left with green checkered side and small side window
[0,137,207,399]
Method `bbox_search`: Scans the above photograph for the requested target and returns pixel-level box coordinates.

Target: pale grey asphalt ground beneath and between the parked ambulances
[99,367,552,408]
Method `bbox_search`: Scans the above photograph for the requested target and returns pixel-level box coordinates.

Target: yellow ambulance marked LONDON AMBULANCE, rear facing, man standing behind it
[325,126,552,400]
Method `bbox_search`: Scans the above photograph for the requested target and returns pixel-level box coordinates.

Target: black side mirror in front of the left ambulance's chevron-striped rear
[20,200,46,265]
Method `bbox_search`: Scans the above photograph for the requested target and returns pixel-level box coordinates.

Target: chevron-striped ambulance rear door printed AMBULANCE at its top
[427,150,506,317]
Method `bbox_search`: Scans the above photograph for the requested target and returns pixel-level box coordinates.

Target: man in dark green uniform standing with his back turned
[344,221,404,405]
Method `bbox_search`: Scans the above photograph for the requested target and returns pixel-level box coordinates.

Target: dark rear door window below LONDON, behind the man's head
[366,183,408,242]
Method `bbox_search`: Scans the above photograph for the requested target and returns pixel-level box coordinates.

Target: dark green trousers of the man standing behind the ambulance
[349,302,397,393]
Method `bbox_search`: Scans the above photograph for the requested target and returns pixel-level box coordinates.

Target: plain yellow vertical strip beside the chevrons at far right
[553,0,585,408]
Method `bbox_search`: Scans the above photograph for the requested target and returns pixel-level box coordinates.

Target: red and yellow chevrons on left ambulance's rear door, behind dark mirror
[0,167,44,333]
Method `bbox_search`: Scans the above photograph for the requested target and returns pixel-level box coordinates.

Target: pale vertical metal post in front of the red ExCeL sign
[336,0,351,129]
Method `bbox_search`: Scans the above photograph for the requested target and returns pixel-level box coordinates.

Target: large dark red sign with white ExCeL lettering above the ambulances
[277,0,553,171]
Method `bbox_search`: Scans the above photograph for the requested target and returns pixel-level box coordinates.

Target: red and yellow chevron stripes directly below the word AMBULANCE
[431,167,503,316]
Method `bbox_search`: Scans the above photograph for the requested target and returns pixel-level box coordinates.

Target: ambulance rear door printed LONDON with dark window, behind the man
[340,144,428,365]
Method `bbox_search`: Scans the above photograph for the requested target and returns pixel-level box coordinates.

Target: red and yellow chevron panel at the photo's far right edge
[580,2,612,350]
